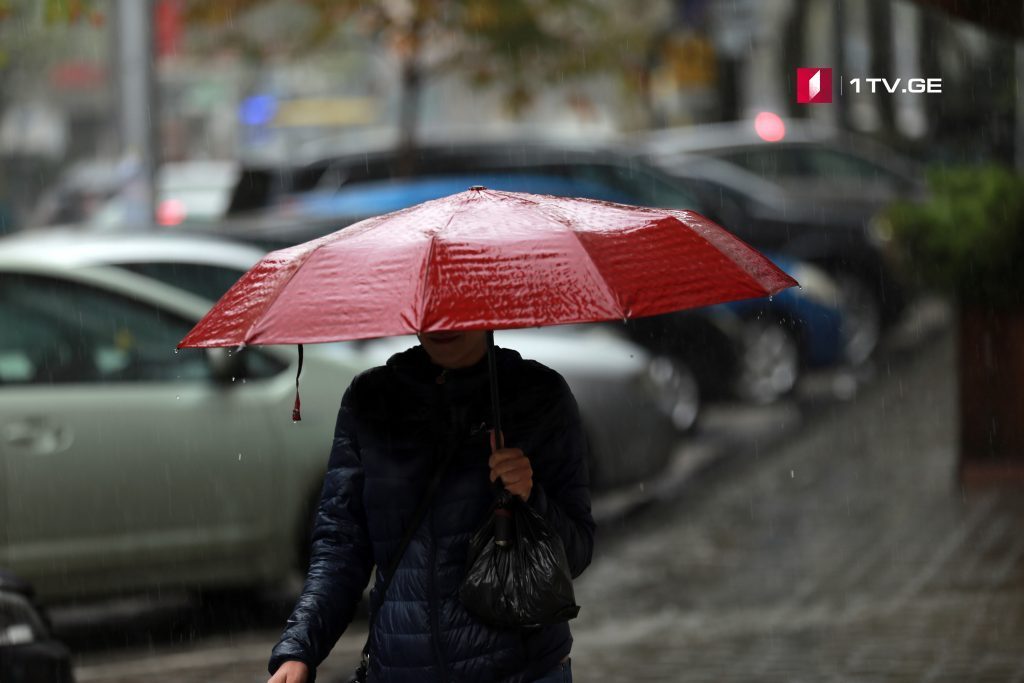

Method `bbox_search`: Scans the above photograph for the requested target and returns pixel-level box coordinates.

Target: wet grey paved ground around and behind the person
[62,327,1024,683]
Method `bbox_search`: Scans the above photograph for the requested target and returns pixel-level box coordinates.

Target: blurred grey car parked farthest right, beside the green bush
[637,122,923,364]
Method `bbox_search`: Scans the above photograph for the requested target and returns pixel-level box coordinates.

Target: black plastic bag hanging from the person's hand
[459,492,580,629]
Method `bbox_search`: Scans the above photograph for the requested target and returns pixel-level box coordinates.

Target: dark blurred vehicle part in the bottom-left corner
[0,569,75,683]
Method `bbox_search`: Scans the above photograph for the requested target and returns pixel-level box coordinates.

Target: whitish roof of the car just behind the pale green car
[0,229,264,269]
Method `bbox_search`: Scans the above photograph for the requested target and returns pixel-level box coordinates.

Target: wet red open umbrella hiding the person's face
[178,186,797,347]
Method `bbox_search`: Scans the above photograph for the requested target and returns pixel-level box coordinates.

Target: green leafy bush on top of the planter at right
[884,166,1024,306]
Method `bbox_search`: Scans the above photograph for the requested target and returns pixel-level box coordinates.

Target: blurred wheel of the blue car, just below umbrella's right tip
[735,317,800,403]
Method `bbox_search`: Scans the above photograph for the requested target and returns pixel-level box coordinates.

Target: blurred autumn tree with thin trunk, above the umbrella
[184,0,672,173]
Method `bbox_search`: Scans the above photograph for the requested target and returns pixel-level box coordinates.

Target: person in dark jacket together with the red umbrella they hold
[179,186,797,683]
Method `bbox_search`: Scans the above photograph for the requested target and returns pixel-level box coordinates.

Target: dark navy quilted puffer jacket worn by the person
[269,346,594,683]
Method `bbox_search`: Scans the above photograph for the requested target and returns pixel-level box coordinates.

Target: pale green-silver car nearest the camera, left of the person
[0,254,361,600]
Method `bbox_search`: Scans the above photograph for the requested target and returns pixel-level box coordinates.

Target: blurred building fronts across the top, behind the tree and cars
[0,0,1024,231]
